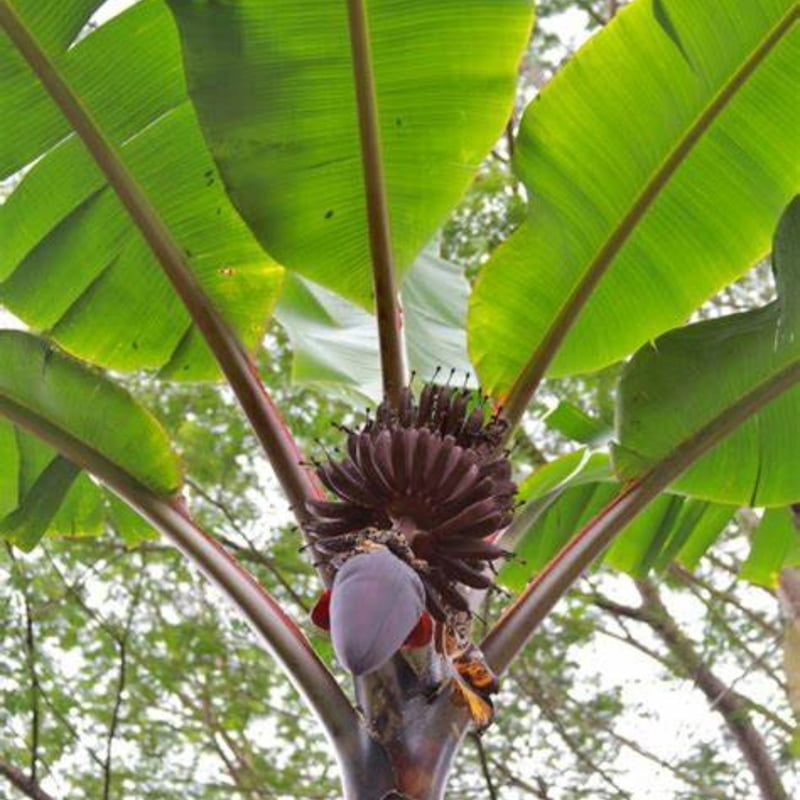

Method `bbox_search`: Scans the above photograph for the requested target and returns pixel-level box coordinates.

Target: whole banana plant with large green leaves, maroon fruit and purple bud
[0,0,800,800]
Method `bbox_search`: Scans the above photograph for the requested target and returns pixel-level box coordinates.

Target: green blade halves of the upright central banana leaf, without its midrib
[169,0,532,309]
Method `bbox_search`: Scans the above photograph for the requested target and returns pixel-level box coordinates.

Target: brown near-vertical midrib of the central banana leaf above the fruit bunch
[347,0,406,408]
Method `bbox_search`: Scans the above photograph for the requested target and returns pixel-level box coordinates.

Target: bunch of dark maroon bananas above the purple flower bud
[307,383,516,621]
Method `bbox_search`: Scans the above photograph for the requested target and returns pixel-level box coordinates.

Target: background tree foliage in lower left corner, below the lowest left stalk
[0,528,337,800]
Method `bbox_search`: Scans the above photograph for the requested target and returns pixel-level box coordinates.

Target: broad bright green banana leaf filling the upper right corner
[469,0,800,401]
